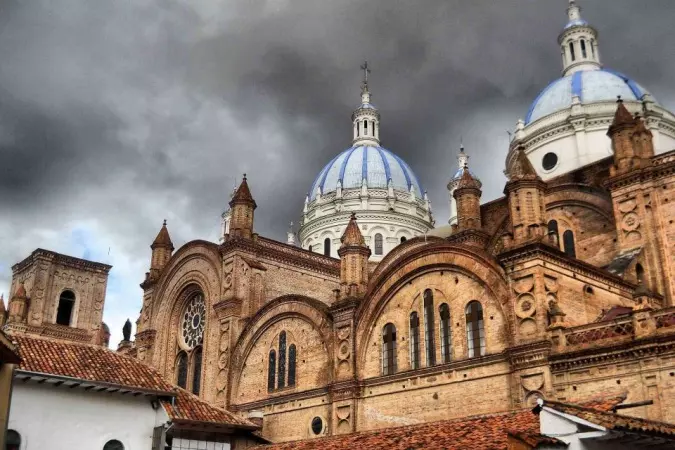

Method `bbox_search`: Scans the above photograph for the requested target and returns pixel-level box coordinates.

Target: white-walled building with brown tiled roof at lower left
[8,336,265,450]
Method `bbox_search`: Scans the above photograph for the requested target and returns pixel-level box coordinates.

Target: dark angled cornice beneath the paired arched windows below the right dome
[497,242,635,292]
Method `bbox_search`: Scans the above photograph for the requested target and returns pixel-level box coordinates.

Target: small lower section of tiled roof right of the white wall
[161,387,258,429]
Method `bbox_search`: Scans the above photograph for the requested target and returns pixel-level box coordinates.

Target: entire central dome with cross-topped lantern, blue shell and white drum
[298,65,434,261]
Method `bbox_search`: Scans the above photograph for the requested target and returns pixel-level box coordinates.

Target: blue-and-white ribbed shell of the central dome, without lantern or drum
[309,145,424,200]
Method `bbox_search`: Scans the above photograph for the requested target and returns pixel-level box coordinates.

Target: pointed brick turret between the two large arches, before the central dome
[338,213,370,297]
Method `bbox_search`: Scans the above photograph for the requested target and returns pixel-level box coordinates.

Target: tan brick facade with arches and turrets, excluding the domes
[121,105,675,441]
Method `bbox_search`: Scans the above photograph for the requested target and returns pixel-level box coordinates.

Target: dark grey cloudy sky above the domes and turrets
[0,0,675,347]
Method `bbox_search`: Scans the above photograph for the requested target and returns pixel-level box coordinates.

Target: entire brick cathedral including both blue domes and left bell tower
[6,0,675,442]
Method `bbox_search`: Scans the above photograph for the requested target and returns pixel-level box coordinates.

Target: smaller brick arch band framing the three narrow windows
[228,295,333,403]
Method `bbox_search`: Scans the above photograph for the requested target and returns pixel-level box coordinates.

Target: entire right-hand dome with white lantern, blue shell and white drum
[506,0,675,180]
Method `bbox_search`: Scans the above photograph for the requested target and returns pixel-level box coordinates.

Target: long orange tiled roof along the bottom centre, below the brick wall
[254,397,625,450]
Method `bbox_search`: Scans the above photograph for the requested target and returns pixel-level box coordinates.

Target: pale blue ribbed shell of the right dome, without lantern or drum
[525,69,648,124]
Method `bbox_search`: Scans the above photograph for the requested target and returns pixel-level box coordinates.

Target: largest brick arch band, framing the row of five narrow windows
[355,240,514,371]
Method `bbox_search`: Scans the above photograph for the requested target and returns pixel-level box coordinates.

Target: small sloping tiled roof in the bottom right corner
[544,401,675,438]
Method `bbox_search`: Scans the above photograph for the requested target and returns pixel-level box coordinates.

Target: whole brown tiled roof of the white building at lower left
[10,336,257,429]
